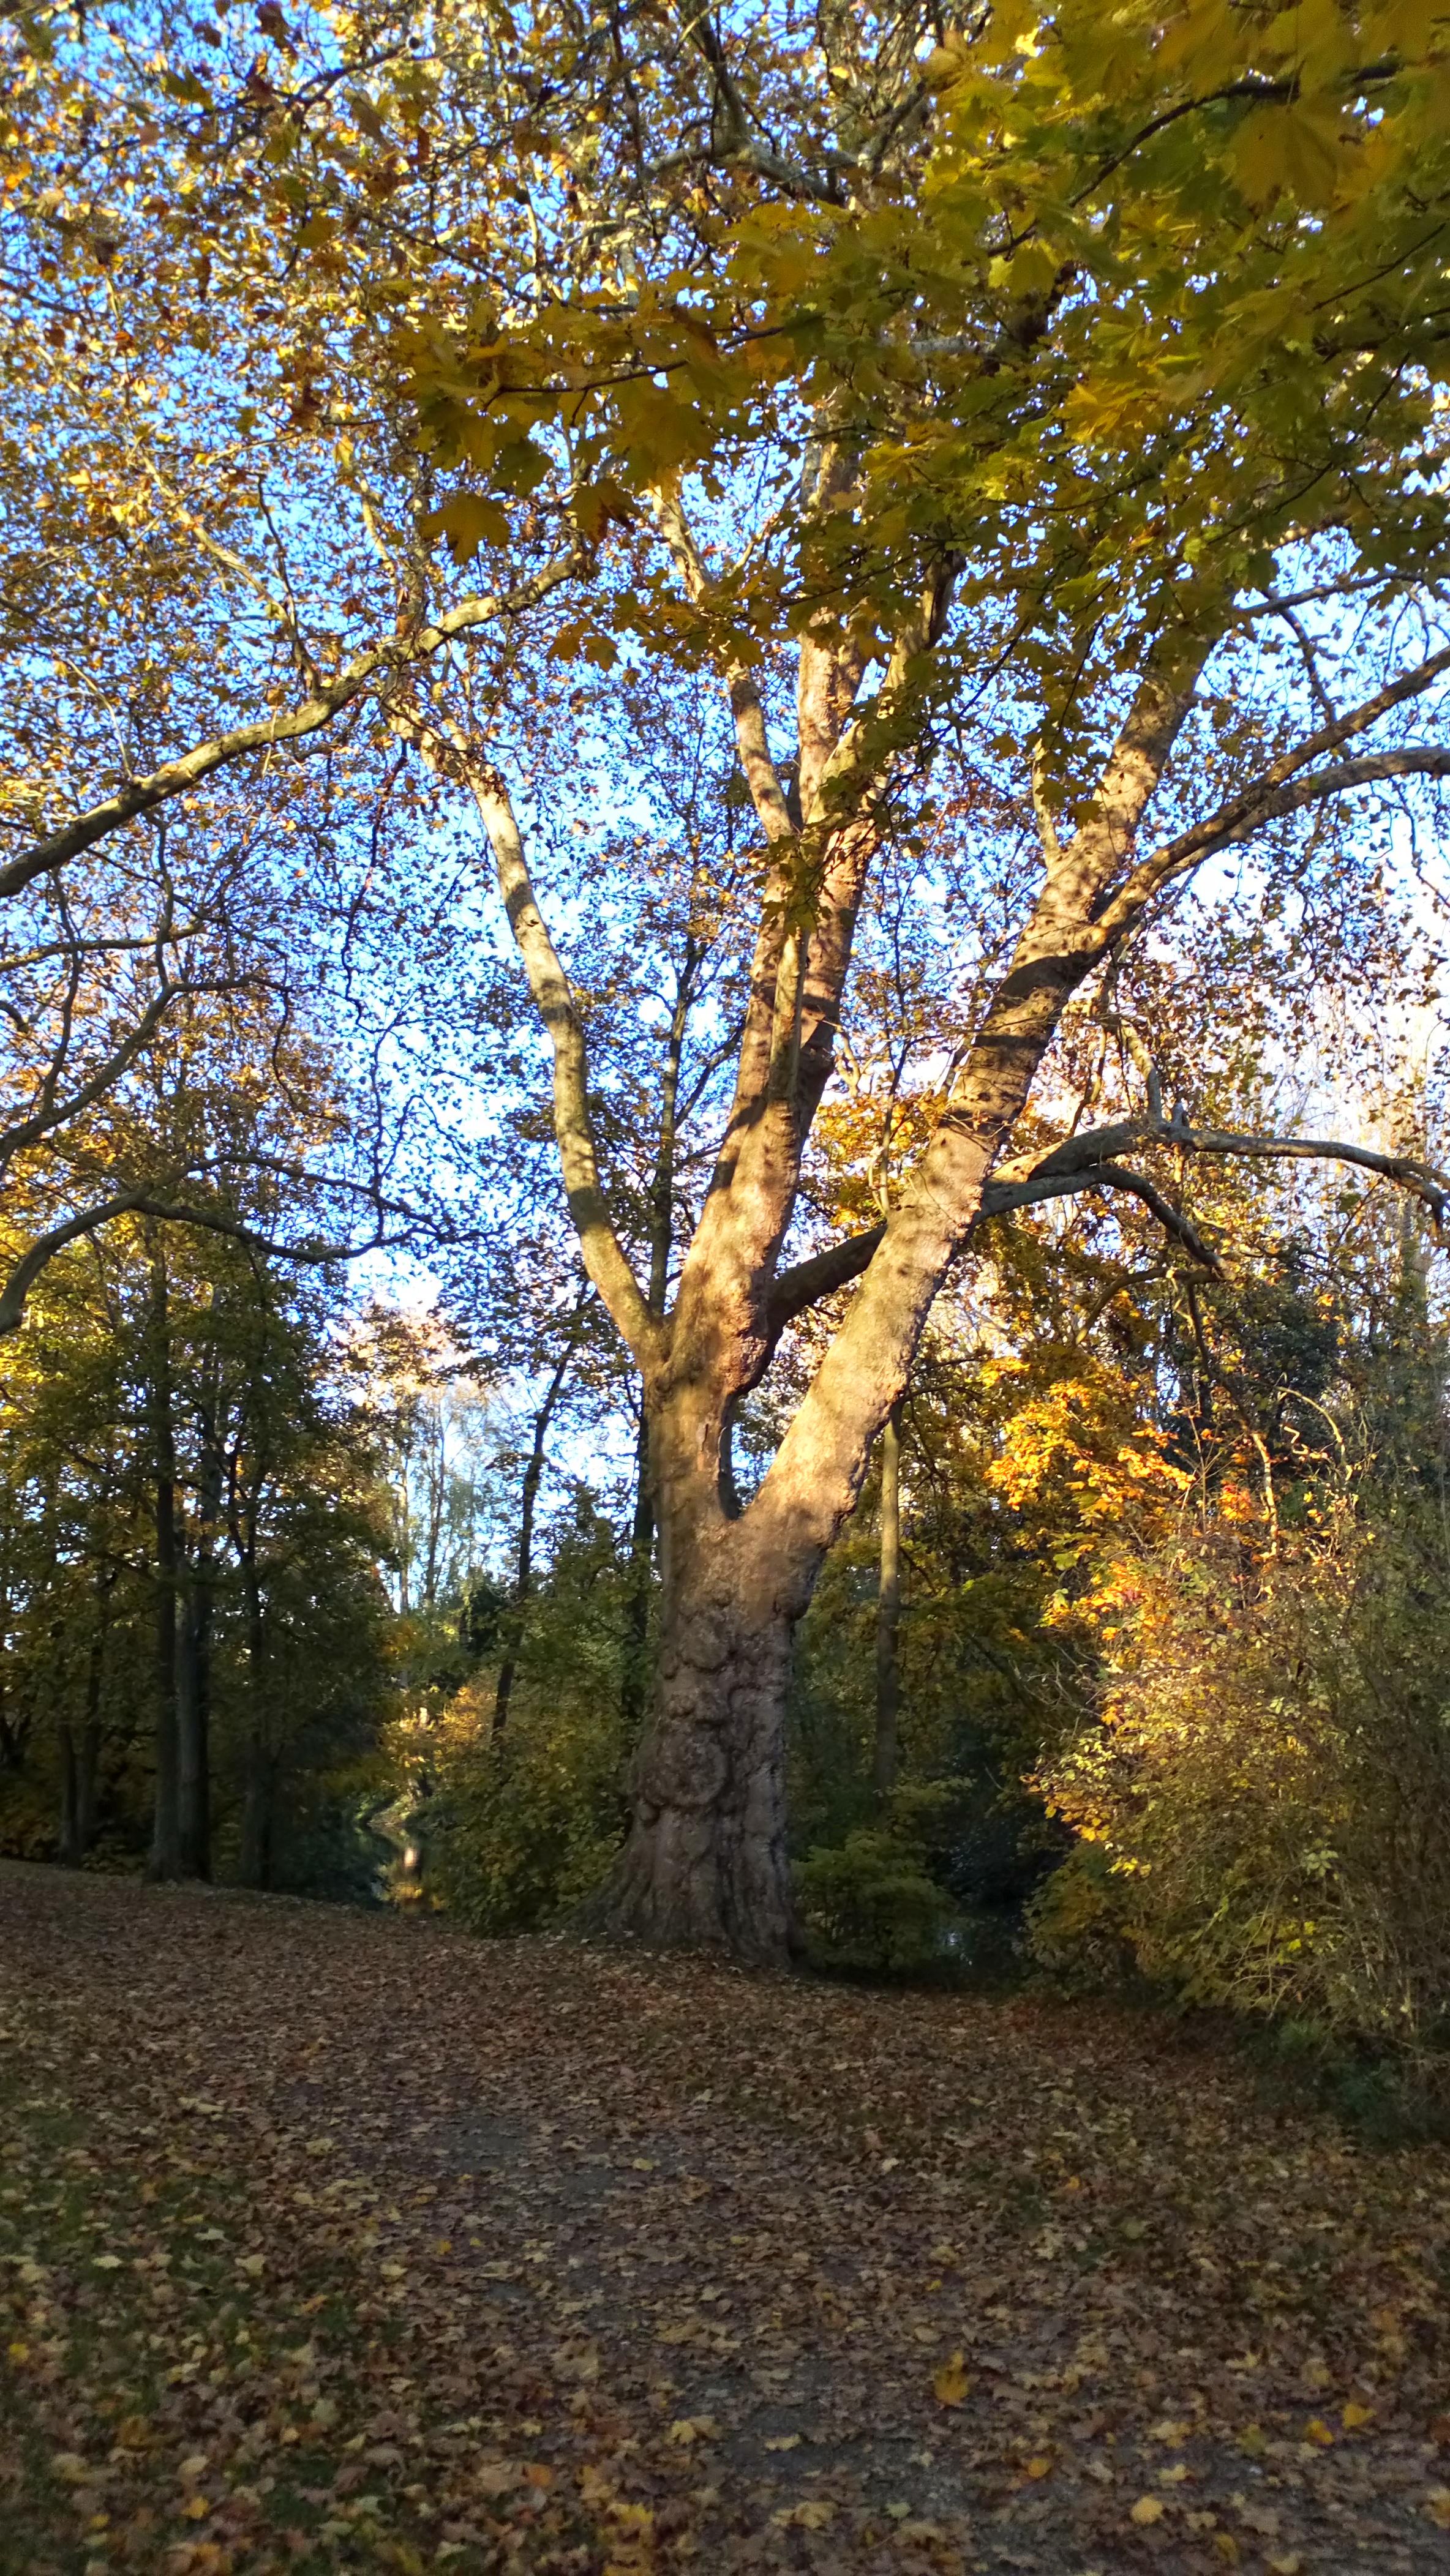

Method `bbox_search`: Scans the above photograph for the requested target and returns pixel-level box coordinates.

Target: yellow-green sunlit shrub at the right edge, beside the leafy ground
[1033,1502,1450,2053]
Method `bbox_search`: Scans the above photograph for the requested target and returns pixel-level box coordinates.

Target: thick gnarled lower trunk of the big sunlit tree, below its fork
[600,1525,796,1968]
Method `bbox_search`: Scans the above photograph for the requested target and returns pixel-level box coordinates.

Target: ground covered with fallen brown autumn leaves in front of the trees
[0,1868,1450,2576]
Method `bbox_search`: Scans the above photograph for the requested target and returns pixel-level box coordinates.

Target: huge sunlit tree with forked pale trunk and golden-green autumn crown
[18,0,1450,1960]
